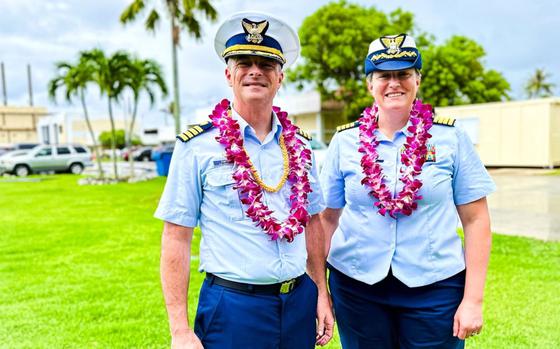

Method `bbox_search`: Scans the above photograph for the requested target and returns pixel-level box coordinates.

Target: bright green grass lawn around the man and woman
[0,175,560,349]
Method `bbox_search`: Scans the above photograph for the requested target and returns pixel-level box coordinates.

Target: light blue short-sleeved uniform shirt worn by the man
[155,110,324,284]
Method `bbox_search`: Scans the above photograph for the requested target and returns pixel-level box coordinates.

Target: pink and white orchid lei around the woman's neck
[358,100,432,218]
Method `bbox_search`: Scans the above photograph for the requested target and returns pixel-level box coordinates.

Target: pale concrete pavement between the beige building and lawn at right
[488,169,560,241]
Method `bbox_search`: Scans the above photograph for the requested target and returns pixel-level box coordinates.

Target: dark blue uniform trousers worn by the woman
[329,267,465,349]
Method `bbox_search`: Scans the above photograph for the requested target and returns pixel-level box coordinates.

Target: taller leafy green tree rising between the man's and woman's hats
[288,1,413,118]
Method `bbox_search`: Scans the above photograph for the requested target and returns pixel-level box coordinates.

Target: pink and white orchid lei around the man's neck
[210,99,311,242]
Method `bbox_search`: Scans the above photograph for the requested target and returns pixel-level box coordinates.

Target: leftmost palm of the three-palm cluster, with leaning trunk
[48,56,103,178]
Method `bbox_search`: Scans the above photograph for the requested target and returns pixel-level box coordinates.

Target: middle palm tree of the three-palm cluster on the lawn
[83,49,131,179]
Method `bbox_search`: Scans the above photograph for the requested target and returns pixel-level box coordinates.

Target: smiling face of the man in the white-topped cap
[225,56,284,104]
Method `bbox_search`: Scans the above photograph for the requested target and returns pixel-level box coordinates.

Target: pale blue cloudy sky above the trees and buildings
[0,0,560,128]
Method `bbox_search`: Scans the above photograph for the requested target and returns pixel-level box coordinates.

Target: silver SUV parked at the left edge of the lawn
[0,144,91,176]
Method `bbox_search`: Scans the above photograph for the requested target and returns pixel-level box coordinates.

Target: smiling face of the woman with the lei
[367,69,420,113]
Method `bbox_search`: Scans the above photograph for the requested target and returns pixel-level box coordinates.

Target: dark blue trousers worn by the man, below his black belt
[194,275,317,349]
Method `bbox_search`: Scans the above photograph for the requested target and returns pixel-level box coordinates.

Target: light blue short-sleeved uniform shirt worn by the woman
[321,122,495,287]
